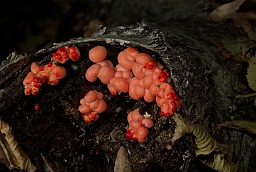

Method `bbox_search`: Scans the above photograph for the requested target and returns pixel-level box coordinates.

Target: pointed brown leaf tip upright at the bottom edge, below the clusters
[114,146,132,172]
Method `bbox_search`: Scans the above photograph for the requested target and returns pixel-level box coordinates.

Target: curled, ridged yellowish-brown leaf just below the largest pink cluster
[171,114,237,172]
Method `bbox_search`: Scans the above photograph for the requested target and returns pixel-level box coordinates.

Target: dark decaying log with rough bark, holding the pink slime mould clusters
[0,19,256,172]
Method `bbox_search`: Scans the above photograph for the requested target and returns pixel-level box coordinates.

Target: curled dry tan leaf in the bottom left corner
[0,120,36,172]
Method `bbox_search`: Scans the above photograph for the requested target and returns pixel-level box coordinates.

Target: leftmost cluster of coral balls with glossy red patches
[23,46,80,95]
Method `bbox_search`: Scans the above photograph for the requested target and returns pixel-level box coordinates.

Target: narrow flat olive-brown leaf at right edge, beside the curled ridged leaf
[218,120,256,134]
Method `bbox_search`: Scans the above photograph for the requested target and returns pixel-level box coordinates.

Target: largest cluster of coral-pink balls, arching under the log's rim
[85,46,182,117]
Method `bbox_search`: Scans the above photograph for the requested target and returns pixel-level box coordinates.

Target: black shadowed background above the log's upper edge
[0,0,212,61]
